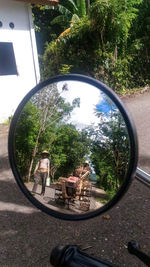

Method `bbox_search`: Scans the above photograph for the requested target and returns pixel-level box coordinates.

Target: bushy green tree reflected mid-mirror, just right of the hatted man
[49,124,88,178]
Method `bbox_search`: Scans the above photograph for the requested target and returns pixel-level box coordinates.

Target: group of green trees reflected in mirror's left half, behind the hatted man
[15,85,88,182]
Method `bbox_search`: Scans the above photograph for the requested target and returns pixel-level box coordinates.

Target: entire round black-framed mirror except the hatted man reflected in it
[8,74,138,220]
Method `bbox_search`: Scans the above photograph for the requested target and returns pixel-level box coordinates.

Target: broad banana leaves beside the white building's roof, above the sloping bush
[32,0,87,55]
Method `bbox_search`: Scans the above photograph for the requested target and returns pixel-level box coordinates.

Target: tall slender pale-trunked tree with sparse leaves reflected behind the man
[28,84,78,182]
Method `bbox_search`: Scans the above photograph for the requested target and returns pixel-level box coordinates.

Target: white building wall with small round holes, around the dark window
[0,0,39,122]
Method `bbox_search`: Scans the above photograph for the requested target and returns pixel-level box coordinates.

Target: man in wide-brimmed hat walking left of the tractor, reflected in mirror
[32,150,50,196]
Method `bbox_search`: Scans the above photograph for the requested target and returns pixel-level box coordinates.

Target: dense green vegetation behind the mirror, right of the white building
[32,0,150,94]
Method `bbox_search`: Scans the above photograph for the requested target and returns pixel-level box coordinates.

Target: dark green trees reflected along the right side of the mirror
[88,98,130,196]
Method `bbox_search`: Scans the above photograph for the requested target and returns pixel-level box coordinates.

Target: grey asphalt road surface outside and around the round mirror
[0,90,150,267]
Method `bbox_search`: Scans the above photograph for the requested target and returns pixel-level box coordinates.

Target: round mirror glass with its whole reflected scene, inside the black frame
[15,80,130,214]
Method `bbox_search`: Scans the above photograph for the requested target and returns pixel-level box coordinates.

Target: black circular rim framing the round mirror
[8,74,138,221]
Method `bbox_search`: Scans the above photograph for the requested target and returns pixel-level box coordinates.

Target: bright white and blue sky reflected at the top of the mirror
[57,81,116,129]
